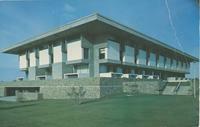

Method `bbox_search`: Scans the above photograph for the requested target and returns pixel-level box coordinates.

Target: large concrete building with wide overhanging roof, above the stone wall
[2,14,198,80]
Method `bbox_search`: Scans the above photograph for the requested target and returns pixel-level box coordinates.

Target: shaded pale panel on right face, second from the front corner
[123,45,135,63]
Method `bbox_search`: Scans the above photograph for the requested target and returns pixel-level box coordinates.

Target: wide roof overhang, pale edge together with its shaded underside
[1,13,199,62]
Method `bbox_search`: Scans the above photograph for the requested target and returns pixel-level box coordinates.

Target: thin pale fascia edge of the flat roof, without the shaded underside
[1,13,199,62]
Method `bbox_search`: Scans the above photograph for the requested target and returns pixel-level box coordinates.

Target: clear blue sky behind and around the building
[0,0,199,80]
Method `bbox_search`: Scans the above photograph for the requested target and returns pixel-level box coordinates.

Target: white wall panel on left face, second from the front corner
[53,45,67,63]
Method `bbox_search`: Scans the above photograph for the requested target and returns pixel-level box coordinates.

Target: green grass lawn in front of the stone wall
[0,95,198,127]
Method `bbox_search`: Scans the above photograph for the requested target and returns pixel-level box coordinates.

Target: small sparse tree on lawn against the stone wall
[68,85,86,104]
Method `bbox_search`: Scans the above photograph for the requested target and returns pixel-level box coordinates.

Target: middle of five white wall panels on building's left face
[39,49,50,65]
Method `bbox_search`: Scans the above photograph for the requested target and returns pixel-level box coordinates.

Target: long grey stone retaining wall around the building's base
[0,77,160,99]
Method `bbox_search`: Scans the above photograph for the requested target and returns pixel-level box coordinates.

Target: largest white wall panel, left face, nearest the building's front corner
[67,40,83,61]
